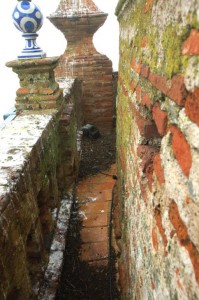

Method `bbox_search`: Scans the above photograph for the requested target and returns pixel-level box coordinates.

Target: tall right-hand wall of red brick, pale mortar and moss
[114,0,199,299]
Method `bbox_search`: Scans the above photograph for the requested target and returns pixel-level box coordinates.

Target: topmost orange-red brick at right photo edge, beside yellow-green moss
[182,29,199,55]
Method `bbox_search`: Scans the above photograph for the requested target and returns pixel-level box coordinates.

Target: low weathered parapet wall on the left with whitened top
[0,80,81,300]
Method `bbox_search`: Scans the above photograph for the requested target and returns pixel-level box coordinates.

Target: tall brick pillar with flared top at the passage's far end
[49,0,113,133]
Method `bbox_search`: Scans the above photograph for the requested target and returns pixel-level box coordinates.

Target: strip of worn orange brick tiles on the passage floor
[76,164,116,267]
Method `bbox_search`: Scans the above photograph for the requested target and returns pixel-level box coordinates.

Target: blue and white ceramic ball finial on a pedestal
[12,0,46,59]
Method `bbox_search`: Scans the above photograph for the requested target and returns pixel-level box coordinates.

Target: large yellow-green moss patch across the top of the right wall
[118,0,194,80]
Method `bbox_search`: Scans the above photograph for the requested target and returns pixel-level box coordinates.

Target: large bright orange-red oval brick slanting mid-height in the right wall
[170,126,192,176]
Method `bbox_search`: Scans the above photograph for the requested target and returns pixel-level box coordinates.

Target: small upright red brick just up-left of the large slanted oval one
[153,103,168,136]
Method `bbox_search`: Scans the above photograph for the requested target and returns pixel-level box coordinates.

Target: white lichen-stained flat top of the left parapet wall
[0,114,52,196]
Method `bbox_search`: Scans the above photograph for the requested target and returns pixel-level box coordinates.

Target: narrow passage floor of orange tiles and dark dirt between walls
[56,135,119,300]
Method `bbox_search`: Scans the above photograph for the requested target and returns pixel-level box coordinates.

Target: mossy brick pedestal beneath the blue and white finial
[6,57,63,112]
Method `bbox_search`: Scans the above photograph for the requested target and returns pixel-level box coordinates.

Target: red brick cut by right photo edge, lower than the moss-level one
[185,88,199,126]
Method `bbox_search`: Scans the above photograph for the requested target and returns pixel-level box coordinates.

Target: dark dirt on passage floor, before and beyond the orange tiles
[56,132,119,300]
